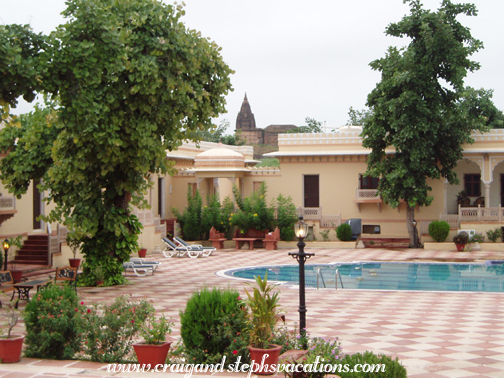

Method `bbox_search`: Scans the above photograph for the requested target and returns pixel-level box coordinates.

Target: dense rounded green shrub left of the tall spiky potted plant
[178,288,249,364]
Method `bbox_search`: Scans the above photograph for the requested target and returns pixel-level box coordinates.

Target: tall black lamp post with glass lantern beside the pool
[289,217,315,349]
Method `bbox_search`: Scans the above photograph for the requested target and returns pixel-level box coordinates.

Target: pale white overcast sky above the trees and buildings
[0,0,504,131]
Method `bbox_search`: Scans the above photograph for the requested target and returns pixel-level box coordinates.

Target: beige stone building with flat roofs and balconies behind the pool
[0,126,504,266]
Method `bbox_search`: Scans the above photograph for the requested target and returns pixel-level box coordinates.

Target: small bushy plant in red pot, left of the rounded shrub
[133,314,173,368]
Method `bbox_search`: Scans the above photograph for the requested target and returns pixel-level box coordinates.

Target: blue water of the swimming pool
[225,262,504,292]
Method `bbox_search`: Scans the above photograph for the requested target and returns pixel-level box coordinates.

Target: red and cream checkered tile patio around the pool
[0,249,504,378]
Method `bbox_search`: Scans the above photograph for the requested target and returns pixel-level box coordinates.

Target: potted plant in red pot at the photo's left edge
[0,300,24,363]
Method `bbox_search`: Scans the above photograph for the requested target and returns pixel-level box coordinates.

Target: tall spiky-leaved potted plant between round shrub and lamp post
[245,273,282,375]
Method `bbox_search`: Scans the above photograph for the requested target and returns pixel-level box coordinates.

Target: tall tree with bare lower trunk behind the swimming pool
[362,0,502,246]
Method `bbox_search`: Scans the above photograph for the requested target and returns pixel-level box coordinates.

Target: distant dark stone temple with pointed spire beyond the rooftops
[236,94,296,146]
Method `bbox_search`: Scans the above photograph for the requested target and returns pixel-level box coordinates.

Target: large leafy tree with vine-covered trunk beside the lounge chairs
[0,0,232,284]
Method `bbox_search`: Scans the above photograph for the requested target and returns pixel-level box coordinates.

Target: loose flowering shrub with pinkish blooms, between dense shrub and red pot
[82,296,155,363]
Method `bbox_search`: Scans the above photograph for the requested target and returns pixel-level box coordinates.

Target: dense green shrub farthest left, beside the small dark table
[23,286,83,360]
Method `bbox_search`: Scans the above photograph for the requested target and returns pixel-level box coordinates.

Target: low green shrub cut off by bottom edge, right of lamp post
[336,351,407,378]
